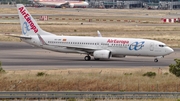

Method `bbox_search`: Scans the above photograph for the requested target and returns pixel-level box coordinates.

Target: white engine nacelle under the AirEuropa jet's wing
[93,50,111,59]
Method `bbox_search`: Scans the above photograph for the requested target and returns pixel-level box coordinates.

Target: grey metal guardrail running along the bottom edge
[0,91,180,99]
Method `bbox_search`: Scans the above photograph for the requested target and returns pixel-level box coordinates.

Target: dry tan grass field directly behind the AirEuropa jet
[0,23,180,47]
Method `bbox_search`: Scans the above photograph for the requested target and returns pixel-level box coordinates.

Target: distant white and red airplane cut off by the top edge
[33,0,89,8]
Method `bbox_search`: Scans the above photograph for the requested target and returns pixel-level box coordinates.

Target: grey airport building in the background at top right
[88,0,180,9]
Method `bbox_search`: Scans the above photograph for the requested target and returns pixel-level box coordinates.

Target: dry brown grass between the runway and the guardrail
[0,67,180,92]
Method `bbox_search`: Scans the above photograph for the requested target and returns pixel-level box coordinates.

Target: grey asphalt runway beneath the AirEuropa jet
[0,42,177,70]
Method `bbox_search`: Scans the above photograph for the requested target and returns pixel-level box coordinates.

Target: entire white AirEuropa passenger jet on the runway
[12,4,174,62]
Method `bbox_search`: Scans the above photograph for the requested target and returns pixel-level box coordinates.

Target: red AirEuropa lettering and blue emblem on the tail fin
[19,6,38,34]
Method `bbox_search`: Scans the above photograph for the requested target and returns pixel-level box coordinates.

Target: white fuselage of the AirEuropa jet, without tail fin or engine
[23,35,173,57]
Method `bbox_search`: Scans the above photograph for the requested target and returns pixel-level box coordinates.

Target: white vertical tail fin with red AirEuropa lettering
[17,4,42,36]
